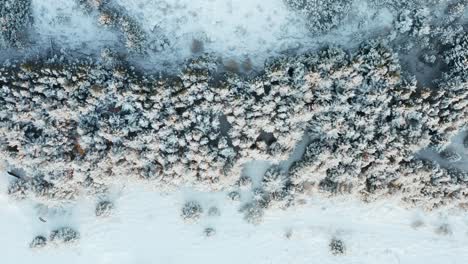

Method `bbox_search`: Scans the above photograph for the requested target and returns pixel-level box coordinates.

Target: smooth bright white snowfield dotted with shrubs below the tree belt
[0,170,468,264]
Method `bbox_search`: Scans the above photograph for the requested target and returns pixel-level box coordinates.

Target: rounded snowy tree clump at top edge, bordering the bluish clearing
[284,0,353,33]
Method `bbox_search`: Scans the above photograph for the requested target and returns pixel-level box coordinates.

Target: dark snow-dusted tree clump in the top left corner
[0,0,32,48]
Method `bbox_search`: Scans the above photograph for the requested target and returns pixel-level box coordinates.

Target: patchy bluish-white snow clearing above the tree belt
[29,0,393,68]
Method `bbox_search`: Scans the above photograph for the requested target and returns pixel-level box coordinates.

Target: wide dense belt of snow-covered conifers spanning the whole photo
[0,35,468,210]
